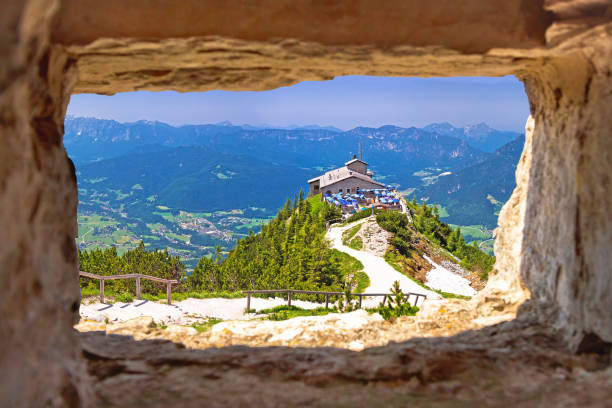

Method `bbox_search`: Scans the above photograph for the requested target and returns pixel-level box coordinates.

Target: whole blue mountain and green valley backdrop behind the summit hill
[64,117,518,269]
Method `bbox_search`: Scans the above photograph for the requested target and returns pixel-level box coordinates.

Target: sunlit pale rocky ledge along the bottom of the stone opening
[75,299,515,351]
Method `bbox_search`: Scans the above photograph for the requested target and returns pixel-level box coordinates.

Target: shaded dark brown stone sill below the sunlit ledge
[81,322,612,407]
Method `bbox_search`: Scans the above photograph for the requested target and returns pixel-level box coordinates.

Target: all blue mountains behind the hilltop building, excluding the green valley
[64,116,523,237]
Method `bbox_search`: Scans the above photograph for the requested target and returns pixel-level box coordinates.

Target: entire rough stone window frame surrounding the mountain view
[0,0,612,406]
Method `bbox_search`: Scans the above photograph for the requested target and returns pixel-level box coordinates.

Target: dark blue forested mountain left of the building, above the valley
[77,145,315,213]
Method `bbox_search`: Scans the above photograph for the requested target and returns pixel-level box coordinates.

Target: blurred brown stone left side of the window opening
[0,0,86,407]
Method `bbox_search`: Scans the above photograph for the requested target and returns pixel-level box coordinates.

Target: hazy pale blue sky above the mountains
[68,76,529,132]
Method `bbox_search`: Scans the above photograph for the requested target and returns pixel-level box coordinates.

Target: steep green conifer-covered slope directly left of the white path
[189,192,356,291]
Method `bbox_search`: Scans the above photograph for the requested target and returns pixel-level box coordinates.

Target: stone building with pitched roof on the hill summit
[308,156,386,196]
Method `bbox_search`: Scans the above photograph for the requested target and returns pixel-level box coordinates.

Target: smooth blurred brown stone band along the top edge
[53,0,552,53]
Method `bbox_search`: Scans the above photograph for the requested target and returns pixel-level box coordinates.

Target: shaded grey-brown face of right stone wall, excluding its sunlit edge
[520,32,612,349]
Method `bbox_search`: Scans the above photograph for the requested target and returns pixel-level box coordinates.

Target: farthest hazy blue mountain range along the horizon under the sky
[64,117,518,181]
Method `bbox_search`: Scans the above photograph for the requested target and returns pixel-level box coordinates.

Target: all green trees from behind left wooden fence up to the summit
[79,191,346,294]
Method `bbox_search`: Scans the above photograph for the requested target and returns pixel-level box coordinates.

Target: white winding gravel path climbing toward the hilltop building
[326,218,441,303]
